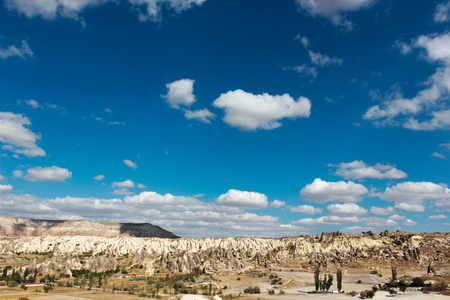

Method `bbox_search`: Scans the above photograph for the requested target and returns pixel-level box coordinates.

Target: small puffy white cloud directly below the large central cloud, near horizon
[216,189,268,209]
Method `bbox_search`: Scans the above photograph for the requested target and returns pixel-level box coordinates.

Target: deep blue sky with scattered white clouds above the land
[0,0,450,238]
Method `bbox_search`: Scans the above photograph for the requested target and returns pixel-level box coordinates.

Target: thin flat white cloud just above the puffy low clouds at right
[330,160,407,179]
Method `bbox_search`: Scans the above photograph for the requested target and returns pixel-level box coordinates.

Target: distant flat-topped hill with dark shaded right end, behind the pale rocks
[0,216,179,239]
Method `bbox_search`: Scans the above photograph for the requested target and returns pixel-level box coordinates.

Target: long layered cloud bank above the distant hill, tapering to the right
[0,185,308,238]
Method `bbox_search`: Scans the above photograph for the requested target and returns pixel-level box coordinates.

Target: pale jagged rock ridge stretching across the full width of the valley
[0,232,450,275]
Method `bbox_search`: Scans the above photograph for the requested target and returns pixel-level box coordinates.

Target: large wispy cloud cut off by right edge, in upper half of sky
[363,33,450,131]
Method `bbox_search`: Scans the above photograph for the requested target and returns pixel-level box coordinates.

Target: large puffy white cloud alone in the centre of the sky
[213,90,311,130]
